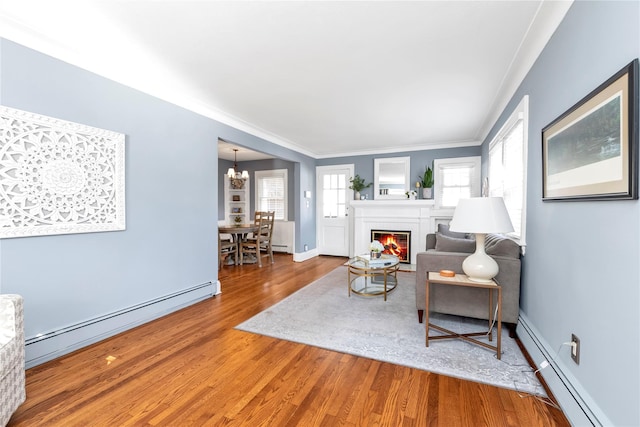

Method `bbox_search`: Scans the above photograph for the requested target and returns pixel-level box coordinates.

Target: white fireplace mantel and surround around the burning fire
[349,200,453,264]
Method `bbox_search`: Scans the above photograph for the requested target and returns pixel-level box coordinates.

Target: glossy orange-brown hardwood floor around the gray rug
[9,254,569,427]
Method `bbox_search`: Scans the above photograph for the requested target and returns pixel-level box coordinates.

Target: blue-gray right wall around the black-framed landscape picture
[483,1,640,426]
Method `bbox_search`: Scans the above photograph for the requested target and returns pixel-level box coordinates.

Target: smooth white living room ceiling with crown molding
[0,0,571,160]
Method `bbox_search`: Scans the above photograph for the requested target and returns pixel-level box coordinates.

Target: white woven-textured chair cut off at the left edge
[0,294,26,426]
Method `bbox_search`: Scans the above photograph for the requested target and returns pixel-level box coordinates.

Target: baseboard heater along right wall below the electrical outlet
[517,312,613,426]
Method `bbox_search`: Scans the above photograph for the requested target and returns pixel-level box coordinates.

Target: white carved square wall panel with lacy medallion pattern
[0,106,126,238]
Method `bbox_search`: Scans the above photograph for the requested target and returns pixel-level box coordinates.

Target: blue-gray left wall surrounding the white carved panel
[0,40,220,352]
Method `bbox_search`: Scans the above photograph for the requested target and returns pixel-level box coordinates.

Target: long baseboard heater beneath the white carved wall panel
[25,281,220,369]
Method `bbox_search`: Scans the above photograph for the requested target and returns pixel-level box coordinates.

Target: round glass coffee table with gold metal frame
[347,254,400,301]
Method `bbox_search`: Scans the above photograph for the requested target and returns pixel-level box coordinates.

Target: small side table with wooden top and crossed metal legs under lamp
[425,272,502,360]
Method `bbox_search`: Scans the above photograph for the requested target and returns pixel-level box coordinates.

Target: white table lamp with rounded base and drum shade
[449,197,513,282]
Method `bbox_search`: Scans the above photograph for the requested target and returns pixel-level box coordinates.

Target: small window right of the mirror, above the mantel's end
[433,157,480,208]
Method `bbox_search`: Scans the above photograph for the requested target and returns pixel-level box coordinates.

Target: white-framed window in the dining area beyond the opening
[256,169,288,221]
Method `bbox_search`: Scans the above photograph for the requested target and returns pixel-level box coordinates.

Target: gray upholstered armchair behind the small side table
[416,231,521,335]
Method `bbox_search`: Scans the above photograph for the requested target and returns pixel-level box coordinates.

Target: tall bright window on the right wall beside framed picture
[488,96,529,246]
